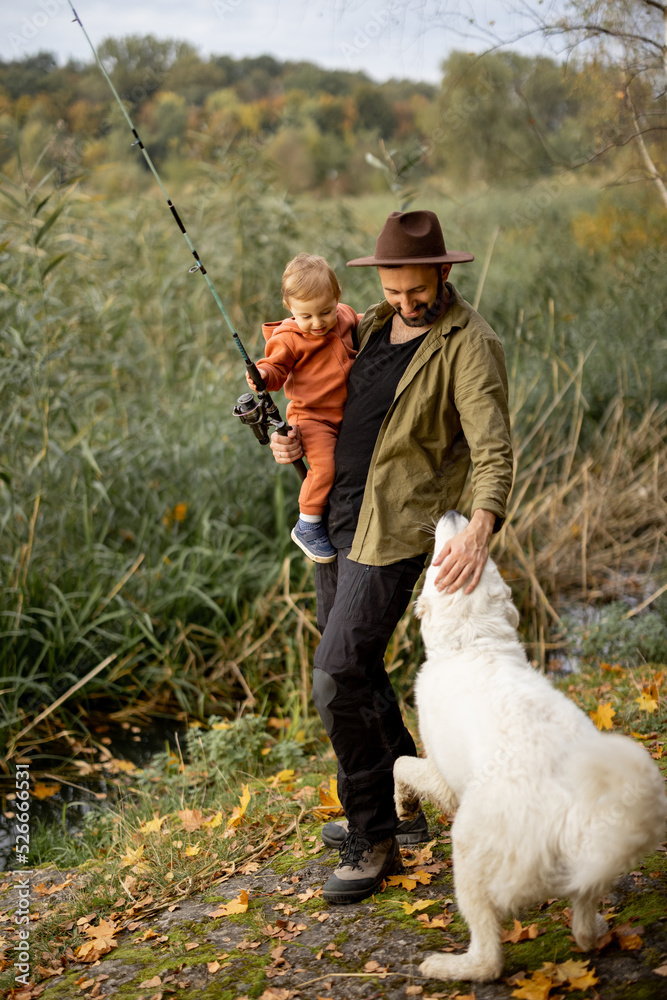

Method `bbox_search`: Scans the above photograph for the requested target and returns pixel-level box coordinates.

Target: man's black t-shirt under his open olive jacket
[328,317,429,549]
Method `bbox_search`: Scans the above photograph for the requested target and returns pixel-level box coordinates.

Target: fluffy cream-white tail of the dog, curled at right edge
[561,733,667,894]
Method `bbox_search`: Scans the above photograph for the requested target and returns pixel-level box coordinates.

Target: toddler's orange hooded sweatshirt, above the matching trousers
[255,303,361,416]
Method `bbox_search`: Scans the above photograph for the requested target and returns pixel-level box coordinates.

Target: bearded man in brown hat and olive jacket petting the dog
[271,211,512,903]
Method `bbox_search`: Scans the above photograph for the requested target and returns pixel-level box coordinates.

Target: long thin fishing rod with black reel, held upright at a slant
[67,0,307,480]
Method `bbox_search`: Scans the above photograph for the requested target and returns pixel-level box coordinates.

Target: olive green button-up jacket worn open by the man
[349,282,513,566]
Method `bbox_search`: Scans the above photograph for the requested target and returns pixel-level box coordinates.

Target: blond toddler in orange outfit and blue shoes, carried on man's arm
[246,253,361,563]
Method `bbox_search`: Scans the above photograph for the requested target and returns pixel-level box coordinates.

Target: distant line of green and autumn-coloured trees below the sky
[0,35,665,194]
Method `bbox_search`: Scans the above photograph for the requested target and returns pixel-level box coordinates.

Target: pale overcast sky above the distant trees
[0,0,554,82]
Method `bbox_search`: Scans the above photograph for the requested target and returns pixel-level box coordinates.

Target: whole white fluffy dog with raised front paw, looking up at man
[394,511,667,981]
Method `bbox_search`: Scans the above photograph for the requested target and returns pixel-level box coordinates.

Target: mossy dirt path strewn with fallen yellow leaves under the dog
[0,836,667,1000]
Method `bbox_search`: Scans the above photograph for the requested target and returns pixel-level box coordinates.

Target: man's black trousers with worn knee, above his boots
[313,549,426,841]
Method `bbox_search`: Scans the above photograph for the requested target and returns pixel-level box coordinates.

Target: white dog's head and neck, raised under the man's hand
[415,510,519,649]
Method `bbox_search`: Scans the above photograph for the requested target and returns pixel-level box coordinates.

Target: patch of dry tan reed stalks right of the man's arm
[500,397,667,601]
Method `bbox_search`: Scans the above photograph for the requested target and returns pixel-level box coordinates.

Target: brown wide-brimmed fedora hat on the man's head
[347,211,475,267]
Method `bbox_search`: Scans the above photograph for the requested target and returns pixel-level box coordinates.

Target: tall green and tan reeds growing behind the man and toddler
[0,158,667,756]
